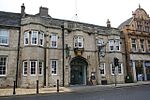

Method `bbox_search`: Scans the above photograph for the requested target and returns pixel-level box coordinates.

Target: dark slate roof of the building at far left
[0,11,21,27]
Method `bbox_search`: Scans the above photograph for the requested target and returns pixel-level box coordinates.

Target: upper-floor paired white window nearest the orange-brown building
[109,40,120,51]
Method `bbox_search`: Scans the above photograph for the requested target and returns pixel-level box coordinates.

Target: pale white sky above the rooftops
[0,0,150,27]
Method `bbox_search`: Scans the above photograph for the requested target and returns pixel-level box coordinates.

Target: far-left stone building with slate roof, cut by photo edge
[0,12,21,87]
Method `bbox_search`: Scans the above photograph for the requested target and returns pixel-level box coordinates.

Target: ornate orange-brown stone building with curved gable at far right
[119,6,150,82]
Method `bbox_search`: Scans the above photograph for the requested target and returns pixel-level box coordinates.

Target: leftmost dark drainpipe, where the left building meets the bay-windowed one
[15,27,21,88]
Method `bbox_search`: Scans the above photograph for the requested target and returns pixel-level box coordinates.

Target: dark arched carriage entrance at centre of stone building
[70,57,88,85]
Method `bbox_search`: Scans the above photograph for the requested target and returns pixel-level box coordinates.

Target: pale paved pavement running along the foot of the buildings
[0,81,150,96]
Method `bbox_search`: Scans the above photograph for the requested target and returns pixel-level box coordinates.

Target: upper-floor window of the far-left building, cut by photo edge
[0,29,9,45]
